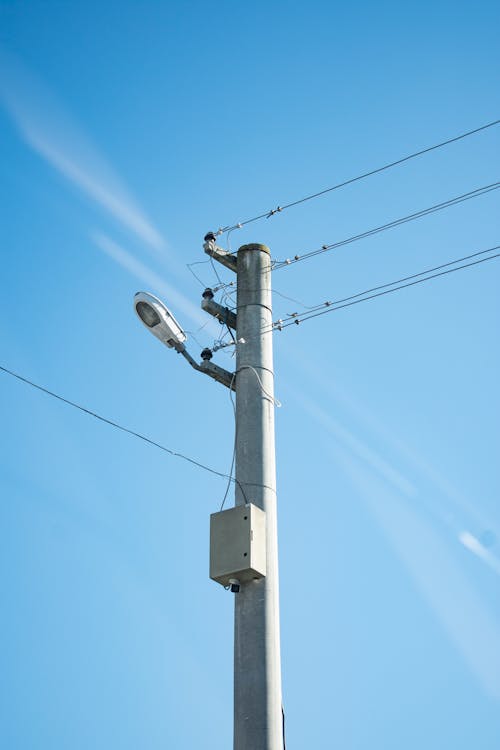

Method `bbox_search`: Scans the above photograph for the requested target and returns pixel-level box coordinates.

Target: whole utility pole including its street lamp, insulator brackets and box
[134,239,284,750]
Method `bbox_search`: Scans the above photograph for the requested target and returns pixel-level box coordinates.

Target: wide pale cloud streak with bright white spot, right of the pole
[294,382,500,701]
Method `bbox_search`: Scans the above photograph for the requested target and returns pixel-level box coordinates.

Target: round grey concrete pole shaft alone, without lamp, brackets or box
[234,245,283,750]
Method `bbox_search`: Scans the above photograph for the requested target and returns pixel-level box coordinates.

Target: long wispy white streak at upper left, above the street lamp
[0,50,165,251]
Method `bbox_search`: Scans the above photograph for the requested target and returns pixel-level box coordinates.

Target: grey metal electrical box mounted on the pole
[210,503,266,586]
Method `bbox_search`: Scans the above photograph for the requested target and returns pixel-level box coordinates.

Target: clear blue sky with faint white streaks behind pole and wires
[0,0,500,750]
